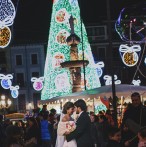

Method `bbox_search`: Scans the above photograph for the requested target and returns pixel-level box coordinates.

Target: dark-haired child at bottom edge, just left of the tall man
[106,127,124,147]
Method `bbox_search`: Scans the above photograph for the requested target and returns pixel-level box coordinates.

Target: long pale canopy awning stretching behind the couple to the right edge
[39,84,146,104]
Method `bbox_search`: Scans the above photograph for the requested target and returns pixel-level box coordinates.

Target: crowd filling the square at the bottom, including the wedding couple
[0,92,146,147]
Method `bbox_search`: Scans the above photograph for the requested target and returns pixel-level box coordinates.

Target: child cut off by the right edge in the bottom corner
[138,127,146,147]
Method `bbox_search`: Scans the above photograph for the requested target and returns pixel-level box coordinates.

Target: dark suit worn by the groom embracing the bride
[66,112,92,147]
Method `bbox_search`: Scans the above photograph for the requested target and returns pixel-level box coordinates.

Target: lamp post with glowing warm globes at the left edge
[0,95,12,120]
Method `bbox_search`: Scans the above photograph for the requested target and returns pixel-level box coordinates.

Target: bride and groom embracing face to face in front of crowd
[55,99,92,147]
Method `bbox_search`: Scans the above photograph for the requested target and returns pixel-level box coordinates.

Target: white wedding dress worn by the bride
[55,113,77,147]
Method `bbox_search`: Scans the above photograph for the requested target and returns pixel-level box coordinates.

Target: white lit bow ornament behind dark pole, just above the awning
[103,75,121,85]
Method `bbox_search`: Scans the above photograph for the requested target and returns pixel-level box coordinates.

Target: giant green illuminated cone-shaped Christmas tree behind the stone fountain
[41,0,101,100]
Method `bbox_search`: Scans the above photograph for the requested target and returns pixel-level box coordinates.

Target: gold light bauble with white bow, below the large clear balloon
[119,44,141,67]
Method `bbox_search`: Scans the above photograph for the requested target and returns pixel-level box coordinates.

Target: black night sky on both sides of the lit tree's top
[12,0,144,41]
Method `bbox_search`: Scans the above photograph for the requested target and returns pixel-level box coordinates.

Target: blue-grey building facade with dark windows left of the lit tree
[9,43,45,111]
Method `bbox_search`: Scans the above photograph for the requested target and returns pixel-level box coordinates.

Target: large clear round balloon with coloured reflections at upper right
[115,2,146,44]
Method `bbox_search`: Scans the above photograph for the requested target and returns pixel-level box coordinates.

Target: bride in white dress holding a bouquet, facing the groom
[55,102,77,147]
